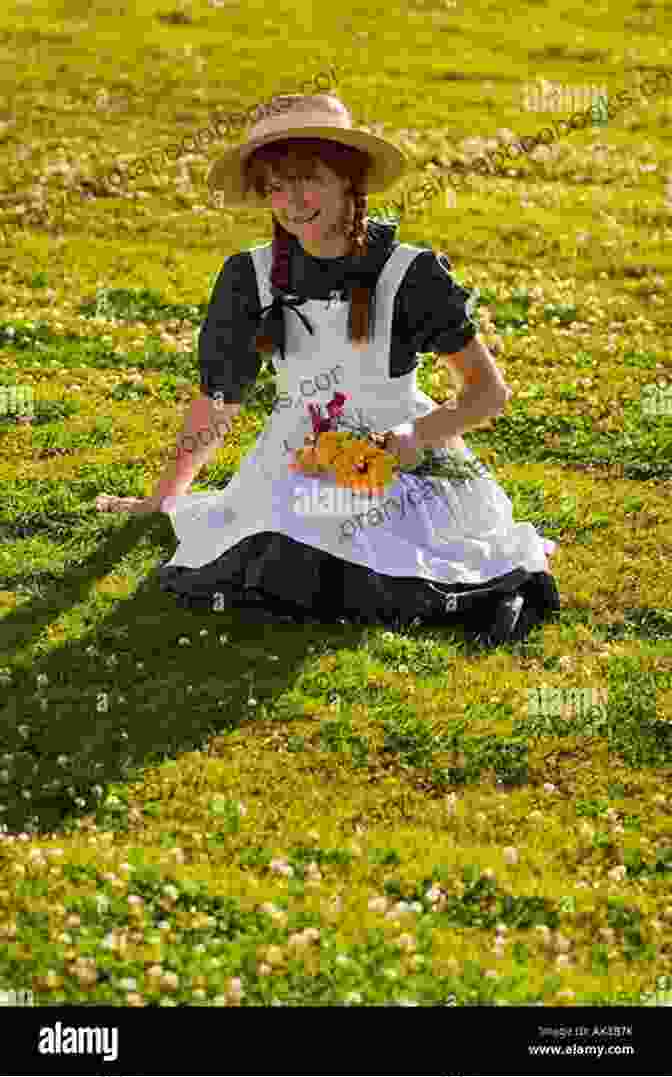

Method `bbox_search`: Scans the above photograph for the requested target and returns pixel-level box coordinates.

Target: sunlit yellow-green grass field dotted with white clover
[0,0,672,1006]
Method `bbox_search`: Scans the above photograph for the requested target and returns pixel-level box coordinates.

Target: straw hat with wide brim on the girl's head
[208,94,407,208]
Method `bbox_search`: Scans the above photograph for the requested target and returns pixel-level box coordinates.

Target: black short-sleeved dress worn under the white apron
[158,220,560,647]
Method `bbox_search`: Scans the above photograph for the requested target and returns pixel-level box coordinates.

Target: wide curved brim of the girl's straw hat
[208,126,408,208]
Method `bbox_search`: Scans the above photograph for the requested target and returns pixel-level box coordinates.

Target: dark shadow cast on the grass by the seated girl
[0,508,493,833]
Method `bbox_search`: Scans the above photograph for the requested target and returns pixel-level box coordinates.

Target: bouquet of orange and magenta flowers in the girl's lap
[290,393,482,495]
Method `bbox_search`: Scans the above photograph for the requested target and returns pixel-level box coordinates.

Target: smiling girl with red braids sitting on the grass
[98,95,560,646]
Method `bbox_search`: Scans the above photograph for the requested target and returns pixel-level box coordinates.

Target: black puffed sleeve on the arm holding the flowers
[395,250,478,354]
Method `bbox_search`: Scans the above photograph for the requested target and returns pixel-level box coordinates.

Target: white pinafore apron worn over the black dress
[165,243,556,585]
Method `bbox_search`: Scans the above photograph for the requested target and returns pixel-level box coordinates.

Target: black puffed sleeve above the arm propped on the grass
[198,251,262,404]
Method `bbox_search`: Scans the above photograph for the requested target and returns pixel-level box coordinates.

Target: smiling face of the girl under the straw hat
[266,158,353,258]
